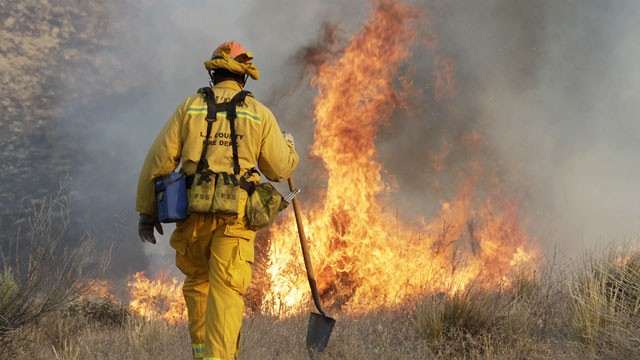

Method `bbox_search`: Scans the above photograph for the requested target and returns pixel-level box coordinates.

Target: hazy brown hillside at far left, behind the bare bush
[0,0,149,272]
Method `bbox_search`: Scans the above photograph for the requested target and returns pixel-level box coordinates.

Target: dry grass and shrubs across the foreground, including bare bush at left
[0,187,640,359]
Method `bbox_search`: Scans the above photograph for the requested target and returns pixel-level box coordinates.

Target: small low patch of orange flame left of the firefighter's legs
[128,271,187,324]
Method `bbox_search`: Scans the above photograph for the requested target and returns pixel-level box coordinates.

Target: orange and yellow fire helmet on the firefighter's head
[204,41,260,80]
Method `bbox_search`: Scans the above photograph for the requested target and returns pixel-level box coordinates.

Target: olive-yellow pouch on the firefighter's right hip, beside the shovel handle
[246,183,289,230]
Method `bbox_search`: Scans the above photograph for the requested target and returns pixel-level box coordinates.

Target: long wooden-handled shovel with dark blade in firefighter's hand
[289,178,336,358]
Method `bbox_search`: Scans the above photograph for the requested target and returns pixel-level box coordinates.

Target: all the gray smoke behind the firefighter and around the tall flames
[52,0,640,273]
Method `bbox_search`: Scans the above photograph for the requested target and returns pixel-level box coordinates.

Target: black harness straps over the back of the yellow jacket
[197,87,251,176]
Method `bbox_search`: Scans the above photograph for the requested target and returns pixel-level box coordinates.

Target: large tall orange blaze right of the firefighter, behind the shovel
[262,0,537,315]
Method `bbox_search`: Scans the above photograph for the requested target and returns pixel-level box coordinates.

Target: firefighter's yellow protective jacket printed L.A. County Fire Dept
[136,81,298,215]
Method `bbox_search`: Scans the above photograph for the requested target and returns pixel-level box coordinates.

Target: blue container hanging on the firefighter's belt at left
[155,172,188,223]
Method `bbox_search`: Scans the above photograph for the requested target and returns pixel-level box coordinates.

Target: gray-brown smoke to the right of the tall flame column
[284,0,640,254]
